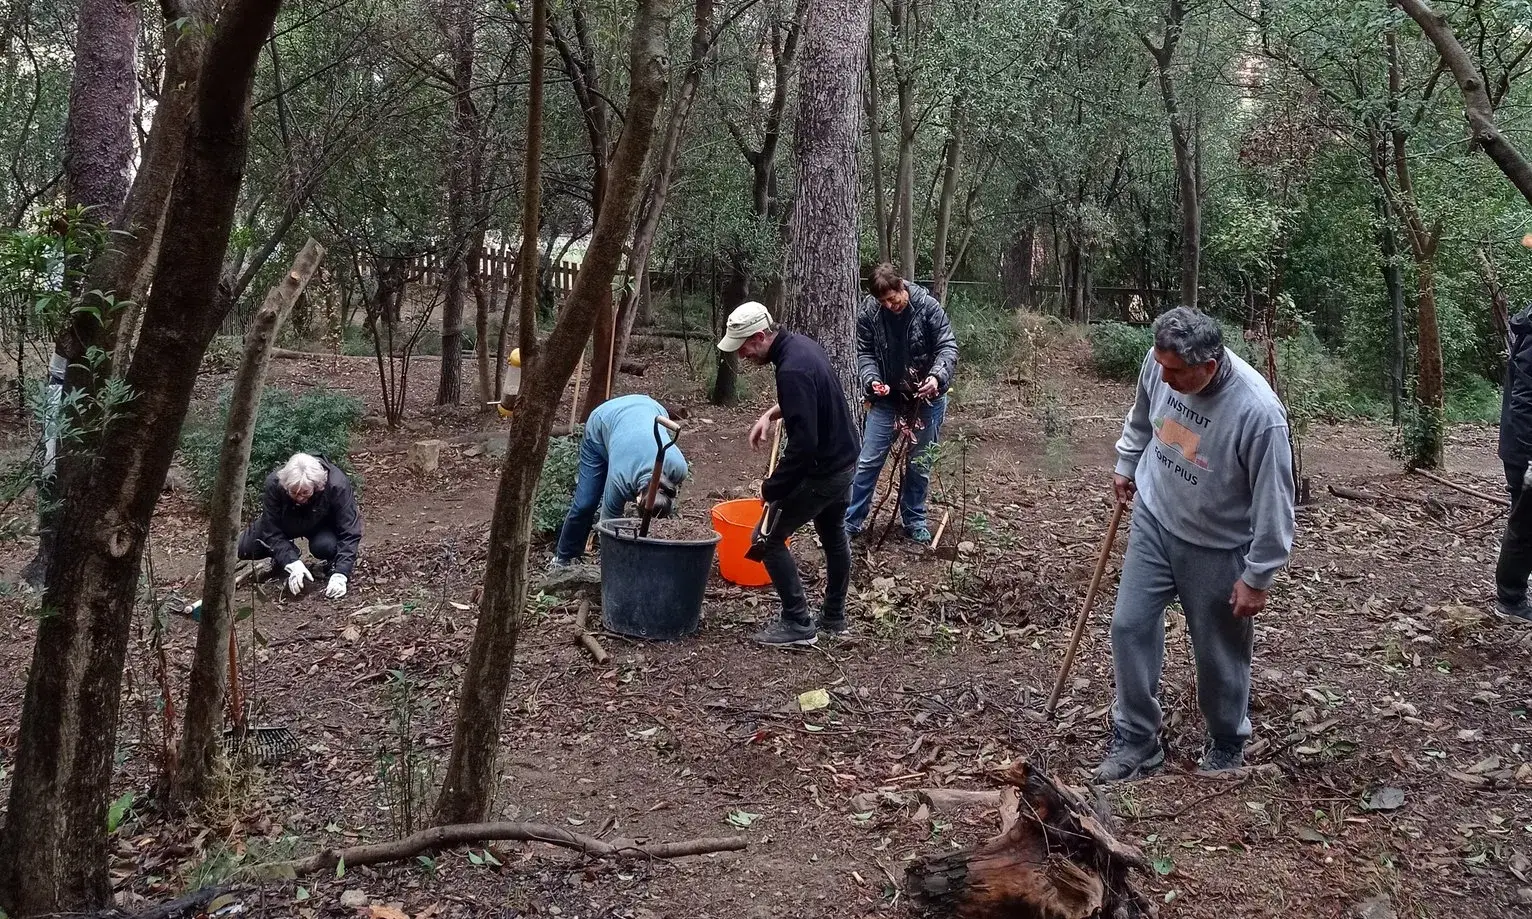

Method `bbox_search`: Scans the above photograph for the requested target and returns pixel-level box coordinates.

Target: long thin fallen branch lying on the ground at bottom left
[269,823,748,878]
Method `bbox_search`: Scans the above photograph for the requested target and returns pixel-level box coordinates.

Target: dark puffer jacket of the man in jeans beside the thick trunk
[856,280,958,397]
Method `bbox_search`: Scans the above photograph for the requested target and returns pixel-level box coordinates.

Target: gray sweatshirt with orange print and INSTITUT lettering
[1117,348,1295,590]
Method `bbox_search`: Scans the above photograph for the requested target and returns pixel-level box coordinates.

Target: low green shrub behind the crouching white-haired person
[181,386,363,502]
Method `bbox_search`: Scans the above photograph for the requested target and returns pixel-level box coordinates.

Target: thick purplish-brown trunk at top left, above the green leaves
[64,0,139,224]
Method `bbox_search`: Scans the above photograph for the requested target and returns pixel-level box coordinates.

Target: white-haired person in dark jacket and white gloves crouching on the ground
[239,453,362,600]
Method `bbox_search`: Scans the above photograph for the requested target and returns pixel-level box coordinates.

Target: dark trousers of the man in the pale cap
[761,467,856,625]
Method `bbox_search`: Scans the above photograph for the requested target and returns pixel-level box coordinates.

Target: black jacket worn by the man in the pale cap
[761,332,861,501]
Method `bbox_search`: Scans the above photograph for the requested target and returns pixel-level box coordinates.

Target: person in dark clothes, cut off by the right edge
[1495,305,1532,620]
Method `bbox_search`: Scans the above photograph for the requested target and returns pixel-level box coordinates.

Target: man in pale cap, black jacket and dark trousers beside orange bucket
[719,302,858,648]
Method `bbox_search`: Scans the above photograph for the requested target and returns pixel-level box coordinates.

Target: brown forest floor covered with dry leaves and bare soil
[0,333,1532,919]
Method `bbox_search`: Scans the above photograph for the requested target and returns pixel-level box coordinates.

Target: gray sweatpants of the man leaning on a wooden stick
[1112,502,1255,749]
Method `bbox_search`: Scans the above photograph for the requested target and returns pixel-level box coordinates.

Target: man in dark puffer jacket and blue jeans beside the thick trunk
[846,263,958,542]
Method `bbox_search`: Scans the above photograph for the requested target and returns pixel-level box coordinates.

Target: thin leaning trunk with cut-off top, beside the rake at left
[176,239,325,801]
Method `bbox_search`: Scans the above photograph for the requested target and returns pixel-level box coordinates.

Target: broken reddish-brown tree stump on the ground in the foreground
[904,761,1157,919]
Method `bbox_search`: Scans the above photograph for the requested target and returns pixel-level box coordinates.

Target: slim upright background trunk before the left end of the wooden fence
[437,0,484,406]
